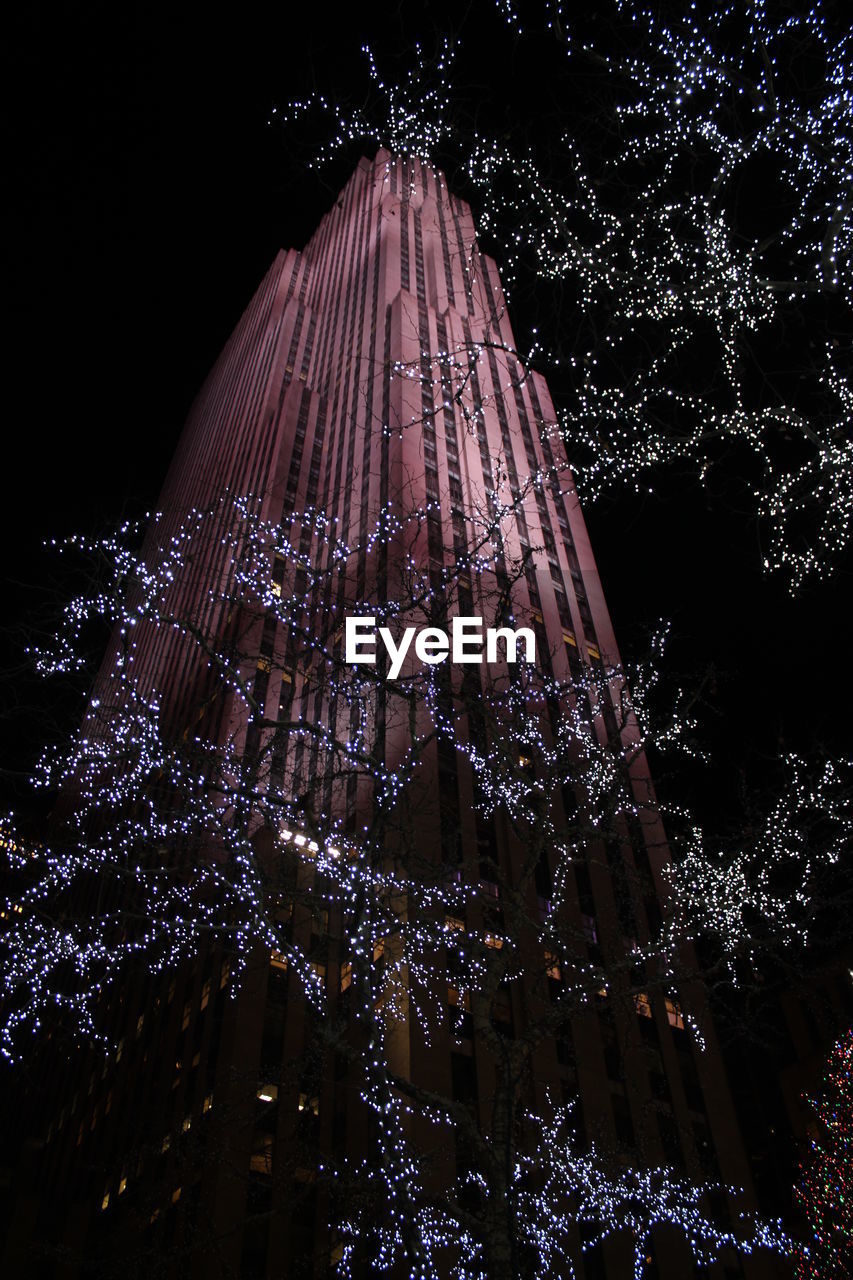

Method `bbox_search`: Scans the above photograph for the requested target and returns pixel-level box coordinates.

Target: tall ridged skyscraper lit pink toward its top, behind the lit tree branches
[6,152,767,1280]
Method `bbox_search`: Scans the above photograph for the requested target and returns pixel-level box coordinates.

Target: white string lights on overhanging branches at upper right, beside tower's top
[275,0,853,591]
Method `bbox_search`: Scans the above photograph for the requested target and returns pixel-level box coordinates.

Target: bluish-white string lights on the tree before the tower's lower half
[1,481,814,1277]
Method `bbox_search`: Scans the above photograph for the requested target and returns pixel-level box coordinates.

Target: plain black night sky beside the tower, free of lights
[0,4,853,824]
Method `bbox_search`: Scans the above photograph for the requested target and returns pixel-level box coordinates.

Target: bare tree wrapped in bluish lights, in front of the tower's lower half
[4,476,850,1277]
